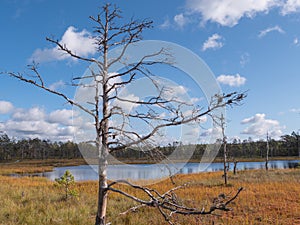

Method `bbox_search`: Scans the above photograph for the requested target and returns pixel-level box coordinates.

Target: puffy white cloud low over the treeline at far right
[241,113,284,138]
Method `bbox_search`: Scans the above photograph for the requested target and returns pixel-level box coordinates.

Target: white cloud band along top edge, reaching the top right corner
[185,0,300,27]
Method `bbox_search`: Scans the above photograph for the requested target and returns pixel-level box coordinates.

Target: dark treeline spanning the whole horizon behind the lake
[0,132,300,161]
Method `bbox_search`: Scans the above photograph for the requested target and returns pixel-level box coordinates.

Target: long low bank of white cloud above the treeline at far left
[1,107,87,141]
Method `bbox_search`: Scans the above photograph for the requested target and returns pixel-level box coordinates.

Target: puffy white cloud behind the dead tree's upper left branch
[30,26,96,62]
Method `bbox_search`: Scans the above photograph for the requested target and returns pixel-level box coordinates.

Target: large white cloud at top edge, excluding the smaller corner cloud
[186,0,279,27]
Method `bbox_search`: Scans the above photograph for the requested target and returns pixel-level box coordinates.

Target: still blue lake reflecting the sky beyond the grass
[39,160,300,181]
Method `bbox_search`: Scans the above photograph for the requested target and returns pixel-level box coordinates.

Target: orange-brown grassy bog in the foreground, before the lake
[0,169,300,225]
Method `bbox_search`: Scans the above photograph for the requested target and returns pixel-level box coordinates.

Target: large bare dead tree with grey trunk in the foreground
[4,4,245,225]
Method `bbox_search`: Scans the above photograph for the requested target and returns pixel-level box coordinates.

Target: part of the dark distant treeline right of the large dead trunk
[114,132,300,160]
